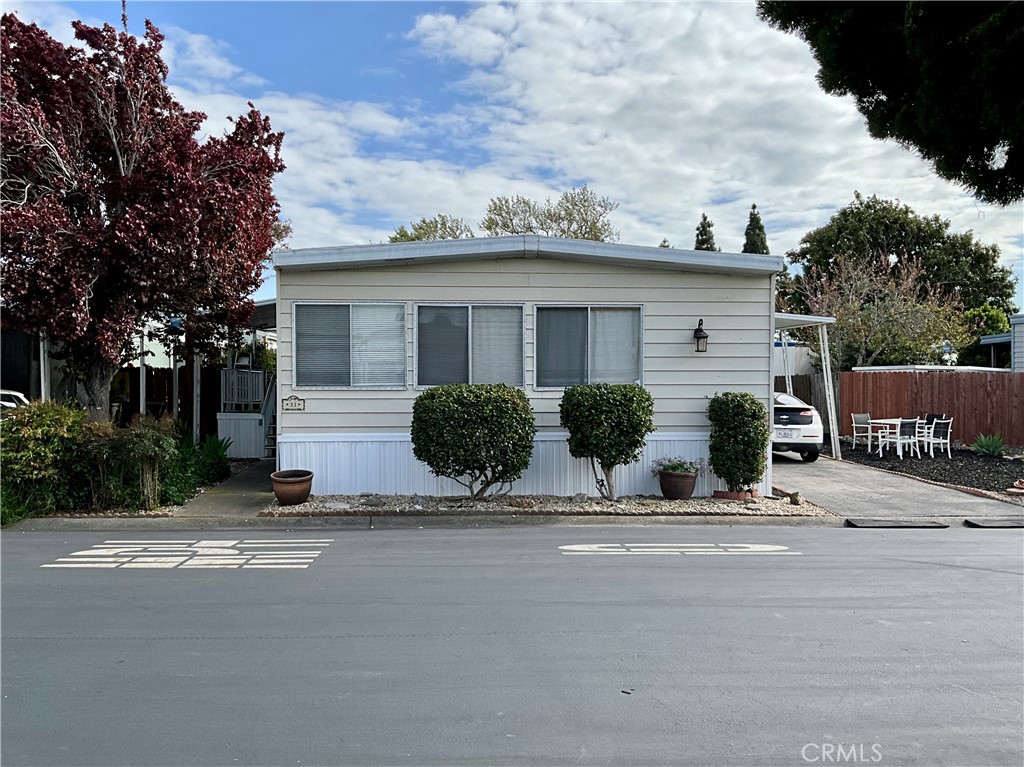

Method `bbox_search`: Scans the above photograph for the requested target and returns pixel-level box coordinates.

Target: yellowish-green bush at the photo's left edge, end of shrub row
[0,401,88,524]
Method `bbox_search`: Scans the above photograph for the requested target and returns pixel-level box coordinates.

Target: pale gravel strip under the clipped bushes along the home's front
[260,495,835,516]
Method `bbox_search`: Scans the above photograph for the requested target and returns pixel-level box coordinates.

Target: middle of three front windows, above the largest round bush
[416,305,523,386]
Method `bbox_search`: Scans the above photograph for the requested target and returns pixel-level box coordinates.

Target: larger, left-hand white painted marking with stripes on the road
[39,538,334,569]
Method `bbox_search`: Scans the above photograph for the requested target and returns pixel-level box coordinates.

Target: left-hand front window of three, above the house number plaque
[294,304,406,388]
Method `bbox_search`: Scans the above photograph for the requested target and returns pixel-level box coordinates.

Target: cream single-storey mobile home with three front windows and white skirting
[274,236,782,496]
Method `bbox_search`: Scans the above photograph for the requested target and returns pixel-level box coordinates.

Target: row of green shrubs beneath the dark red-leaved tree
[0,402,230,525]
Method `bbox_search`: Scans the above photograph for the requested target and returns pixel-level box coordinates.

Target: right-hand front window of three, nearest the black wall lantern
[536,306,643,388]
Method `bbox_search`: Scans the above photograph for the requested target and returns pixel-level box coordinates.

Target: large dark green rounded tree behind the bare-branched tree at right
[786,193,1016,313]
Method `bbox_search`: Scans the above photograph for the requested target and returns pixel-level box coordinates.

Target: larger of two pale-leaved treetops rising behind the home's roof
[480,186,618,243]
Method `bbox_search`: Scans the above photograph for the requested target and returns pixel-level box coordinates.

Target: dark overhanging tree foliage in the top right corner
[758,0,1024,205]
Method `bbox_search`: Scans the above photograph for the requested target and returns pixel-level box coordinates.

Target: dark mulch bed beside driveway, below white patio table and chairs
[831,444,1024,505]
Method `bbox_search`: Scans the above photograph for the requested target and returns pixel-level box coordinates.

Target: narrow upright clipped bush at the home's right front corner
[708,391,770,492]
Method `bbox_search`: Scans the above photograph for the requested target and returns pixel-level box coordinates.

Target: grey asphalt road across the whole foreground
[0,525,1024,767]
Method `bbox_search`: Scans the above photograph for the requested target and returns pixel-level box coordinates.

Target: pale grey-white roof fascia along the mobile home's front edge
[273,235,782,276]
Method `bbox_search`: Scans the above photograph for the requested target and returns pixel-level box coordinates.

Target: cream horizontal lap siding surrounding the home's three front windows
[278,256,773,434]
